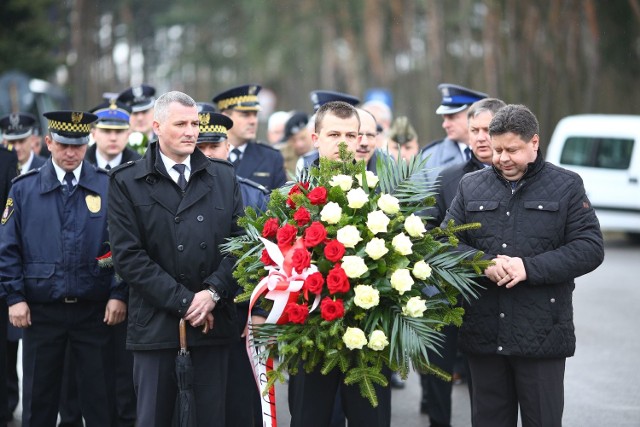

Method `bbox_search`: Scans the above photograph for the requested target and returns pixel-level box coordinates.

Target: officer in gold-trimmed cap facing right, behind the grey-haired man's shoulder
[213,85,287,190]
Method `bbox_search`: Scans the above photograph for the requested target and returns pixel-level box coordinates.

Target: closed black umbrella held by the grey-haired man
[173,319,196,427]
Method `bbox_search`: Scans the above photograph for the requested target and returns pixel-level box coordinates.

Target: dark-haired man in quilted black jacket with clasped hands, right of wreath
[442,105,604,427]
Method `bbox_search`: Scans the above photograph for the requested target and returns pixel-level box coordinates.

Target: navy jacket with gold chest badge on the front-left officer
[0,159,127,305]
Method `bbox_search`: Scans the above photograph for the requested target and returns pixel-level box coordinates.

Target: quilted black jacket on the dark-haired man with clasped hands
[443,154,604,358]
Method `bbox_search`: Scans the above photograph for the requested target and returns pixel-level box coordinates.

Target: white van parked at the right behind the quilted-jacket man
[545,114,640,241]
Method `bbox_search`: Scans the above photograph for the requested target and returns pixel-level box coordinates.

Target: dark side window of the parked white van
[560,136,634,169]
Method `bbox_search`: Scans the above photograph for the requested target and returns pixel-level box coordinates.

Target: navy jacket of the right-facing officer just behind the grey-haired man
[235,142,287,190]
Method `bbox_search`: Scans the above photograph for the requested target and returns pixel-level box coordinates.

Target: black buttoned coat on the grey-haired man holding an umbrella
[109,141,242,350]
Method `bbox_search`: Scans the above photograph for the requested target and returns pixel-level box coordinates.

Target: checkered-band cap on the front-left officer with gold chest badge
[43,111,98,145]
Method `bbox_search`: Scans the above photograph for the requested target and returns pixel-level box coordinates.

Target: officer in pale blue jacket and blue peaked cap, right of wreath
[421,83,488,180]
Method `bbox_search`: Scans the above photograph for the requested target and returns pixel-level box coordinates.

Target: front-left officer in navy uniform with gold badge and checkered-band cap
[0,111,127,427]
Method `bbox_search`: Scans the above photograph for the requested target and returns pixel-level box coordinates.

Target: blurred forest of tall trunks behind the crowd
[0,0,640,150]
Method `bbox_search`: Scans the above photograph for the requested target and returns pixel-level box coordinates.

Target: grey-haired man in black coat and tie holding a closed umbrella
[109,92,242,427]
